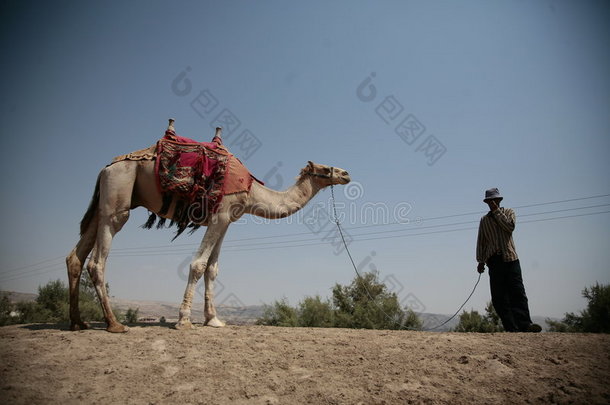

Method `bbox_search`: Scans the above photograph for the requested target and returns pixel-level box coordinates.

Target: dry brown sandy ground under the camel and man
[0,324,610,404]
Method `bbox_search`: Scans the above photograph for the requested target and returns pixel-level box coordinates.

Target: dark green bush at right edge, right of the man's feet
[546,283,610,333]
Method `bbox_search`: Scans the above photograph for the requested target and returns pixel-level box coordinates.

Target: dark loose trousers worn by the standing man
[487,256,532,332]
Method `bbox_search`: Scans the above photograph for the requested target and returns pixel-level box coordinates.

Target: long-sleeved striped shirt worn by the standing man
[477,207,518,263]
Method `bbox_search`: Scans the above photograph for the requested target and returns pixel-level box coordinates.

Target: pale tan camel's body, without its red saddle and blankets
[66,120,350,333]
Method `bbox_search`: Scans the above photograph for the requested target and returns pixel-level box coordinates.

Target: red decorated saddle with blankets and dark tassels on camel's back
[112,120,259,239]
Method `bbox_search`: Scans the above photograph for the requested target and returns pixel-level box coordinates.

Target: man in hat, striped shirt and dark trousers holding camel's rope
[477,188,542,332]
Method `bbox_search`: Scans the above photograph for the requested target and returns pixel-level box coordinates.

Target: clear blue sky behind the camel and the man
[0,1,610,316]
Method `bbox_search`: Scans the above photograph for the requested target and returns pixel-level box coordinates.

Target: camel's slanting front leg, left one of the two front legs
[176,218,230,329]
